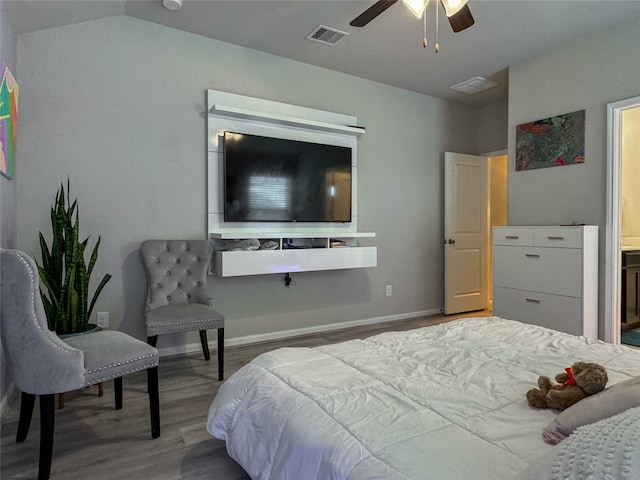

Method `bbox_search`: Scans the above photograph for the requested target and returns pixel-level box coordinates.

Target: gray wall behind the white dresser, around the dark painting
[509,18,640,333]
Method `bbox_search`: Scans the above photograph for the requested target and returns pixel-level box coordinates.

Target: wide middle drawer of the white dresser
[493,245,582,297]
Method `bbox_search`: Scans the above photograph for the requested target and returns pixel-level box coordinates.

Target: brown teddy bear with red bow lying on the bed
[527,362,609,410]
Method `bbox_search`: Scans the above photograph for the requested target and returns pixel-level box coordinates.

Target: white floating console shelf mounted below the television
[210,231,377,277]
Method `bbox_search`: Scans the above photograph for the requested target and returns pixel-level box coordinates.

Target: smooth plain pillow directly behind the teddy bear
[542,376,640,445]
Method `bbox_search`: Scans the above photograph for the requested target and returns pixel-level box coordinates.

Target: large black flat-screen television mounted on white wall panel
[223,132,351,222]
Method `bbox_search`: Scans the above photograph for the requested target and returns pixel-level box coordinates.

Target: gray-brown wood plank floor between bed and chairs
[0,311,490,480]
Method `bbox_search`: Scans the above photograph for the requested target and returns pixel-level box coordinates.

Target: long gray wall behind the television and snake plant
[13,17,480,356]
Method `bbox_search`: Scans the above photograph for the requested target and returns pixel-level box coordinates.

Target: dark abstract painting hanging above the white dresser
[516,110,585,170]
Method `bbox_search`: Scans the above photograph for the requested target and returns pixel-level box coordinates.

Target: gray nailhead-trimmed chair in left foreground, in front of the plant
[0,249,160,480]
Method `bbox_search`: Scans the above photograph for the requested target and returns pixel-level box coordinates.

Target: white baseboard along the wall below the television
[158,308,442,357]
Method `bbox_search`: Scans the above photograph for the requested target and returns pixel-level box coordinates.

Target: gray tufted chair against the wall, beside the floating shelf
[140,240,224,380]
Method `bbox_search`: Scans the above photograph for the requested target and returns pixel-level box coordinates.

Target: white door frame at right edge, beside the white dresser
[604,97,640,344]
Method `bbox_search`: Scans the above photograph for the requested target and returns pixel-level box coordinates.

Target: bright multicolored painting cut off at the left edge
[0,67,18,178]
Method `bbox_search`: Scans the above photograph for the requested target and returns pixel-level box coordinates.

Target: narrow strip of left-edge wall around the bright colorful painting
[0,2,20,405]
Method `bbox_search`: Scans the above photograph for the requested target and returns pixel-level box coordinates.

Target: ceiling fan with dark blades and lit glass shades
[349,0,475,32]
